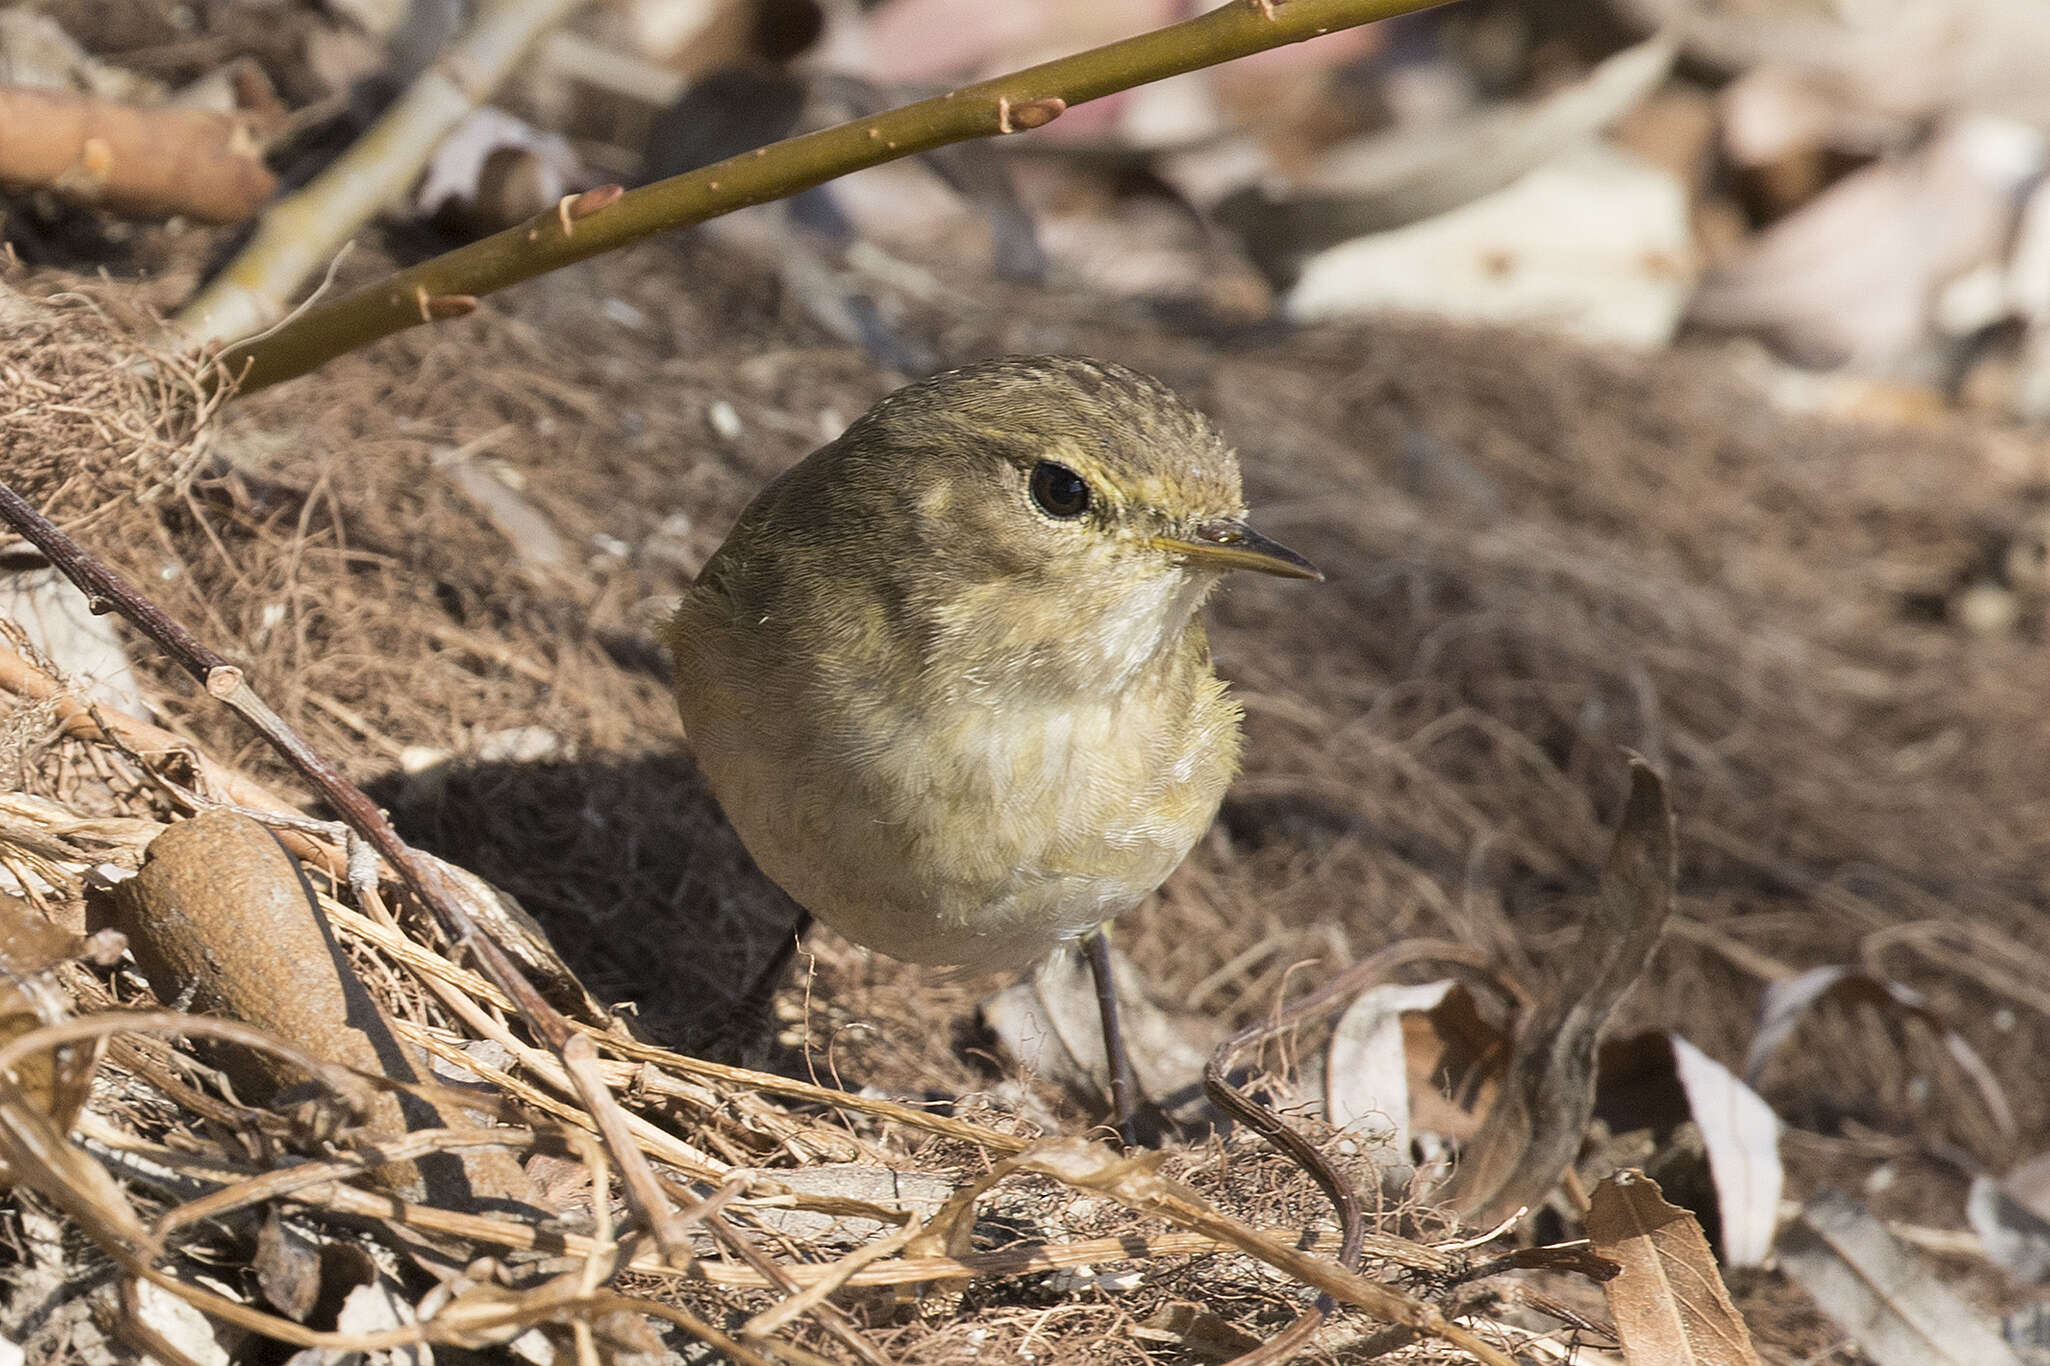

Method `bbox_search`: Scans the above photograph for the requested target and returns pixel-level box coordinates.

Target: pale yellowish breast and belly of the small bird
[685,648,1238,968]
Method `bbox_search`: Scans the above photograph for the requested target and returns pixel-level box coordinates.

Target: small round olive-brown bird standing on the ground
[668,357,1320,1122]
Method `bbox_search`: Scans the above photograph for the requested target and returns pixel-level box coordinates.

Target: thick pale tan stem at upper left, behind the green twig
[178,0,582,340]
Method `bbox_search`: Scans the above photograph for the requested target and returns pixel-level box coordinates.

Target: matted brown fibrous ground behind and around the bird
[12,199,2050,1362]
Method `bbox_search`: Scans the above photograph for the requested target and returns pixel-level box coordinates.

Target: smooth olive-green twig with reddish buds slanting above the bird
[212,0,1437,394]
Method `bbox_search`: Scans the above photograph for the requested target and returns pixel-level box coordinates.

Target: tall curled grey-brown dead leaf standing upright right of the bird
[1443,755,1675,1224]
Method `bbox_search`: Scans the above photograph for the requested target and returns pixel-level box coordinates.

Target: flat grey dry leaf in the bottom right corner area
[1779,1192,2021,1366]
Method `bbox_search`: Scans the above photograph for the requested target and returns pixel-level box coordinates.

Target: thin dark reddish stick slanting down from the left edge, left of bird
[0,484,691,1265]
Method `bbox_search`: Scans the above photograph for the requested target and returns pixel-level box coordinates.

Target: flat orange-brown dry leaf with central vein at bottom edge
[1587,1171,1759,1366]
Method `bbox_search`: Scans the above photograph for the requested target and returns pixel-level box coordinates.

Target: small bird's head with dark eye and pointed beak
[822,357,1322,689]
